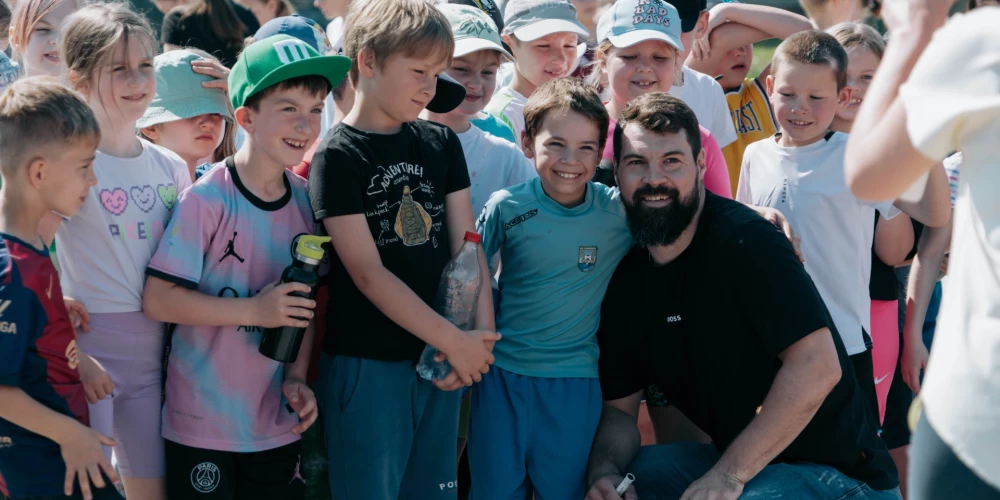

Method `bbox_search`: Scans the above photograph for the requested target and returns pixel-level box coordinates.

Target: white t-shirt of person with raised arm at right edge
[900,7,1000,488]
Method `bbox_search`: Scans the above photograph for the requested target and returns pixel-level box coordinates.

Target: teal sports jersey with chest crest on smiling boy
[476,178,632,378]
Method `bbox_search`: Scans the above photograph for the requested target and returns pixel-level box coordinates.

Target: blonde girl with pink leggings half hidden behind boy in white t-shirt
[827,22,914,423]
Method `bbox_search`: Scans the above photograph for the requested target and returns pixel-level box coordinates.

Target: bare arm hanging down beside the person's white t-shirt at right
[900,223,951,393]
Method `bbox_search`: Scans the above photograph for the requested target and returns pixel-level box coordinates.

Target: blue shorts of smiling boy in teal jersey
[469,366,602,500]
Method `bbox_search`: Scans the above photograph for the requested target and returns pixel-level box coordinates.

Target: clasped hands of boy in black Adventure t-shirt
[434,330,500,391]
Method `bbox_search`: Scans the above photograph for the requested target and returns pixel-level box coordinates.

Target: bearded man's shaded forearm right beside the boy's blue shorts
[587,391,642,500]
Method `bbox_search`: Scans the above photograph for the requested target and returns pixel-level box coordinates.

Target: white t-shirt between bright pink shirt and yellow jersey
[669,66,736,148]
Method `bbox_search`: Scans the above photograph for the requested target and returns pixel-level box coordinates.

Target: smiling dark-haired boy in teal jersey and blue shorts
[469,78,632,500]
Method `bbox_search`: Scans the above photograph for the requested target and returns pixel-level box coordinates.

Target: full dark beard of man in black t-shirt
[623,179,701,250]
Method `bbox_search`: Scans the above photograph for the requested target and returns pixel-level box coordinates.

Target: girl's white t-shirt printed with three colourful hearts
[56,139,191,313]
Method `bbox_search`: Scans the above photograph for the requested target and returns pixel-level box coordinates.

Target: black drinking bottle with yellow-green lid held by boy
[257,235,330,363]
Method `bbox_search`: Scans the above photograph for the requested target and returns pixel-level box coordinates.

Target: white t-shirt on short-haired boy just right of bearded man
[736,132,899,355]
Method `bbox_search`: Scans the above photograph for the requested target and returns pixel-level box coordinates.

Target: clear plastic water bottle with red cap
[417,231,483,380]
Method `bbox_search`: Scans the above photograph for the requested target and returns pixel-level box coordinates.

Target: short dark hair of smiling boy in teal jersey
[524,77,610,152]
